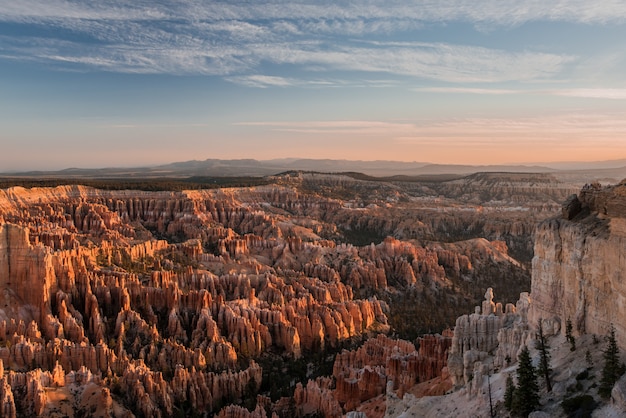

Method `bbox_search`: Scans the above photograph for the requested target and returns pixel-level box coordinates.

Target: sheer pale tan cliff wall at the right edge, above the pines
[530,182,626,347]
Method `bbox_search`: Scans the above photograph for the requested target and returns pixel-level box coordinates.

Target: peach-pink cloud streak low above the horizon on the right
[229,112,626,164]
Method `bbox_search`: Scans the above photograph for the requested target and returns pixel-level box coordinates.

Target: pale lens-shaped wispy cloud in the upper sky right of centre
[247,43,574,82]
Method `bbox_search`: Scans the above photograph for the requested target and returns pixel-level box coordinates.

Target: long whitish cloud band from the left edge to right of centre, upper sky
[3,37,574,86]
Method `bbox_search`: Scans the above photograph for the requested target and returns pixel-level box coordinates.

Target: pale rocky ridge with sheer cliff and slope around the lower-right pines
[385,182,626,417]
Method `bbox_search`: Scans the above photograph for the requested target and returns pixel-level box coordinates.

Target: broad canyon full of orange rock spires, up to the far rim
[0,172,626,417]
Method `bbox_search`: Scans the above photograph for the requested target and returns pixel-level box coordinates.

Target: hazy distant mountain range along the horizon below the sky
[0,158,626,179]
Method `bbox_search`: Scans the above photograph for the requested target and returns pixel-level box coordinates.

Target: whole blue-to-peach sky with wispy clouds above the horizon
[0,0,626,171]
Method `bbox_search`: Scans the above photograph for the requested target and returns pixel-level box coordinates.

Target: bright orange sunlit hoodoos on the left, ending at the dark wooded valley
[0,186,388,416]
